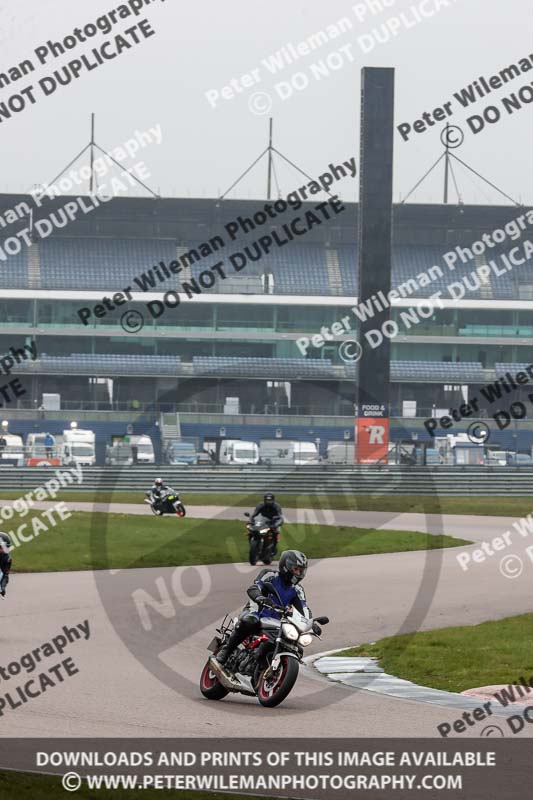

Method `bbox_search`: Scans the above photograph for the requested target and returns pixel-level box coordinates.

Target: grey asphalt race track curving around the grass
[0,503,533,737]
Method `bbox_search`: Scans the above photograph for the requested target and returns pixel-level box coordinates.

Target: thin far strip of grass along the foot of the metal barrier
[0,490,533,517]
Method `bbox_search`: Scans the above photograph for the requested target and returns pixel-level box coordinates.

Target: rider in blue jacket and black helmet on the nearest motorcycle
[215,550,311,666]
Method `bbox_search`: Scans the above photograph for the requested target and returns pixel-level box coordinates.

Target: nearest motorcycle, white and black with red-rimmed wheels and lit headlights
[200,606,329,708]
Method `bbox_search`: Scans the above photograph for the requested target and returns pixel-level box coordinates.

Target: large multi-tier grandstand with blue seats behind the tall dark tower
[0,195,533,460]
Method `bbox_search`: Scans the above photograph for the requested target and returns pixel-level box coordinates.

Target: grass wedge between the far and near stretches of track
[8,512,471,572]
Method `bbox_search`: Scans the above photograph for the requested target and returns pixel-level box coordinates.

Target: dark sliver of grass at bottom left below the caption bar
[0,772,264,800]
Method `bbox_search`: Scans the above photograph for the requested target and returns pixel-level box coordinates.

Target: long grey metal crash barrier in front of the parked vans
[0,466,533,499]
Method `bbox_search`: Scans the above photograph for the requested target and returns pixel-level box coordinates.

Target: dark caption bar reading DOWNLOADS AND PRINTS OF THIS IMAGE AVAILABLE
[0,738,532,800]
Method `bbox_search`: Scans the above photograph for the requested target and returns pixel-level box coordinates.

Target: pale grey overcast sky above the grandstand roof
[0,0,533,204]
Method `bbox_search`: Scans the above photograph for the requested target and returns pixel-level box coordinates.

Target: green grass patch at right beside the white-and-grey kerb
[336,614,533,692]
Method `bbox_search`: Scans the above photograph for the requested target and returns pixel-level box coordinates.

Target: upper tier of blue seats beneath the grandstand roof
[32,237,533,299]
